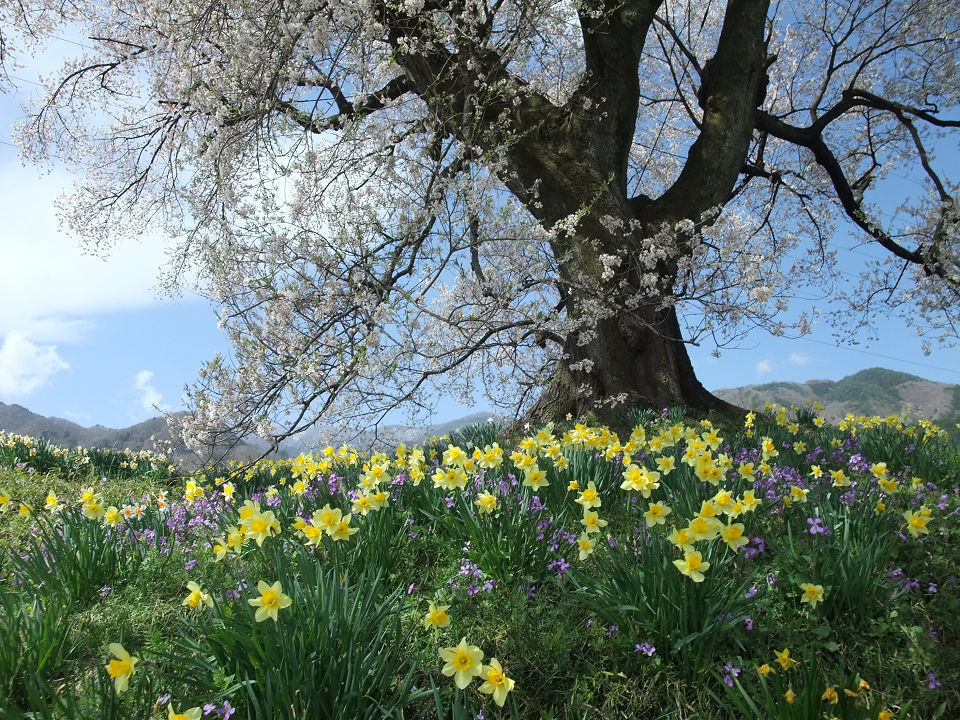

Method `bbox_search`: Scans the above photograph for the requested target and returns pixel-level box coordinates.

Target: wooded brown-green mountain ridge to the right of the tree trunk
[715,368,960,427]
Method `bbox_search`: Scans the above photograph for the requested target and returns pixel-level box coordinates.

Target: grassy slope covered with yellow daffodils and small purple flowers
[0,408,960,720]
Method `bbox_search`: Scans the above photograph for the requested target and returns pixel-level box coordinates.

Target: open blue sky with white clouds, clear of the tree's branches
[0,43,960,427]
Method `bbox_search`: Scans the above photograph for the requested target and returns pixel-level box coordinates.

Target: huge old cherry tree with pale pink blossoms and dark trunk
[0,0,960,442]
